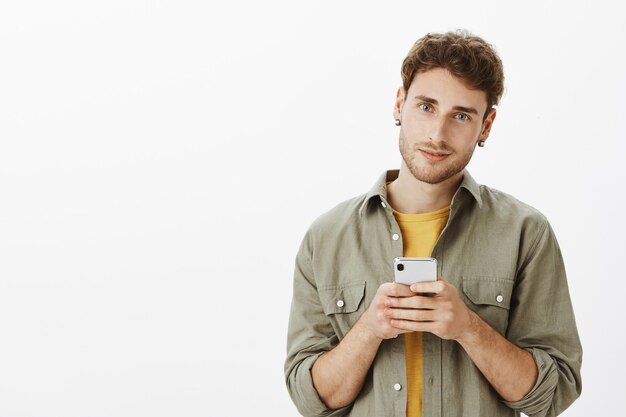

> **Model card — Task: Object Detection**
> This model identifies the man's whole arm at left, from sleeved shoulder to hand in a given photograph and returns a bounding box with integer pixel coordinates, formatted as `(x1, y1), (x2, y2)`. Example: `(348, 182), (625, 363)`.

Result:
(285, 231), (411, 417)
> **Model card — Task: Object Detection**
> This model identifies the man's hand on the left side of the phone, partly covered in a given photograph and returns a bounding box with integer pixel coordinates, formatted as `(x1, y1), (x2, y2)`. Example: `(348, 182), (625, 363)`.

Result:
(360, 282), (415, 339)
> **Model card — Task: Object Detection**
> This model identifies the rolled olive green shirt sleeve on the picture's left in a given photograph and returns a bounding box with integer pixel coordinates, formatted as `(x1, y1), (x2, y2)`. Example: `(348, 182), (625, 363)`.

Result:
(285, 234), (350, 417)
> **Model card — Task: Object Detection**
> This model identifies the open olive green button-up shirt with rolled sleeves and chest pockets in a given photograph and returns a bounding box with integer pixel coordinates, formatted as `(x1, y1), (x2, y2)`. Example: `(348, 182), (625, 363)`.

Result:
(285, 171), (582, 417)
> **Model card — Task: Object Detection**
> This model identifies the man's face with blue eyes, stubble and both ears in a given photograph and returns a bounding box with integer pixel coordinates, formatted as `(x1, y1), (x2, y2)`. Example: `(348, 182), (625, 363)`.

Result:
(394, 68), (496, 184)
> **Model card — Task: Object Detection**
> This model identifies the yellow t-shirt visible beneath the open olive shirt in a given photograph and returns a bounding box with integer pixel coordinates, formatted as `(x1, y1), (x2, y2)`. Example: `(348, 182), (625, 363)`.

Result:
(393, 207), (450, 417)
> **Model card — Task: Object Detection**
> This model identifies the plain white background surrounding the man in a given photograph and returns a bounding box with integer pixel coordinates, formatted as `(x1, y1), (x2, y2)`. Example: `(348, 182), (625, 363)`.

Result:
(0, 0), (626, 417)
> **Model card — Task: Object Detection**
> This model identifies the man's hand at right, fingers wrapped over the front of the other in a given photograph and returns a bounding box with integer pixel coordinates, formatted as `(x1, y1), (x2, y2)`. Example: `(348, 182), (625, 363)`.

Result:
(384, 277), (473, 340)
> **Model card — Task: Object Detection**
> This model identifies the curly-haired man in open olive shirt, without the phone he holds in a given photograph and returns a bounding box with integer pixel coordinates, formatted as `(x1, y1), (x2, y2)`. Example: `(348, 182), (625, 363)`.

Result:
(285, 32), (582, 417)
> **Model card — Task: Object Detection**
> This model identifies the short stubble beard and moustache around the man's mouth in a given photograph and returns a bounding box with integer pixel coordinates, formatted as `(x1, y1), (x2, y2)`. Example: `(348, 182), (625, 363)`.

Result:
(400, 132), (475, 184)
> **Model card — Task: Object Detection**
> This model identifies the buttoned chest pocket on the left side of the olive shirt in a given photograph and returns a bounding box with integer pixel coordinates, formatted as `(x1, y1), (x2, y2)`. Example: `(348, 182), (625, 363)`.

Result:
(318, 281), (365, 339)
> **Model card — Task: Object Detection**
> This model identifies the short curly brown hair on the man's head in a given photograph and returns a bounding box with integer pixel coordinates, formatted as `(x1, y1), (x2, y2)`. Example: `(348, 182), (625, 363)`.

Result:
(401, 30), (504, 117)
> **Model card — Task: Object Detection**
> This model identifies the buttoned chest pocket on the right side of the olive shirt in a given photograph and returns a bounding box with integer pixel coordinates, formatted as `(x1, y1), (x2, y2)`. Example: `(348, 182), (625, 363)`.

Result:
(463, 276), (515, 335)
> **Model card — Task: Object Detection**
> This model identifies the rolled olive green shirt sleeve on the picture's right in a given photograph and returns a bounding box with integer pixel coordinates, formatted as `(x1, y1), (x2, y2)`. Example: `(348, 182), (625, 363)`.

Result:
(504, 219), (582, 417)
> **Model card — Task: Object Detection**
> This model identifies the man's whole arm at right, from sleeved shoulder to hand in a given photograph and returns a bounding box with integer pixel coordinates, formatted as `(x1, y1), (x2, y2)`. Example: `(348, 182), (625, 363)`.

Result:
(386, 219), (582, 416)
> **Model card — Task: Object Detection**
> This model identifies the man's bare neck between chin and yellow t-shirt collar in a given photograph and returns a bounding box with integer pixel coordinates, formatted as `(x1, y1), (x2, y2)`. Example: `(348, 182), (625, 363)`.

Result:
(387, 161), (463, 214)
